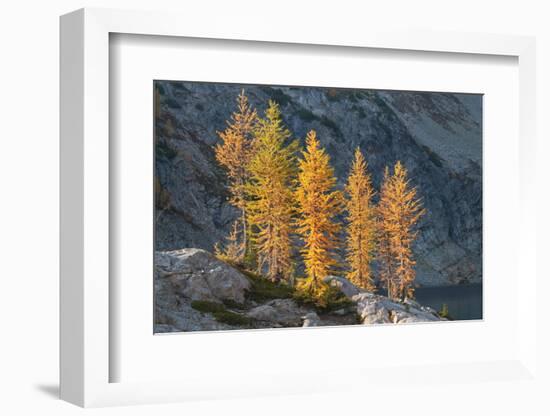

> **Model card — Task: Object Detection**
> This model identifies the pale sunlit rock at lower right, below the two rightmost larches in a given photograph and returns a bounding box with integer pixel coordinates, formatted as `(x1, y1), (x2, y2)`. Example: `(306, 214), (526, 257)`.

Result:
(353, 292), (444, 324)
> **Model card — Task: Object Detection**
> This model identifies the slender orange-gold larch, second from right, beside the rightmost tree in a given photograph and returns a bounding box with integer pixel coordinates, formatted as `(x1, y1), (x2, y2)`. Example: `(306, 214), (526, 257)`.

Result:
(345, 148), (376, 291)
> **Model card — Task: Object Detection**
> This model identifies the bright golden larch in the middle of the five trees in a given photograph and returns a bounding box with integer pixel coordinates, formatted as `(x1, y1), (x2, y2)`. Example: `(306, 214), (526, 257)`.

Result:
(296, 130), (343, 306)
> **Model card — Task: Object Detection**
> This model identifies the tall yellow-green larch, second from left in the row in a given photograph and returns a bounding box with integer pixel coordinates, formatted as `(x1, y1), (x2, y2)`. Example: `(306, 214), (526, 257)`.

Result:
(246, 101), (298, 281)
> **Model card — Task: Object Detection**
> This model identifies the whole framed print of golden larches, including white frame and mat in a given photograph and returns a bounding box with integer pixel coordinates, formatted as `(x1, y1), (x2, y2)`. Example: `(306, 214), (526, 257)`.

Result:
(61, 9), (537, 406)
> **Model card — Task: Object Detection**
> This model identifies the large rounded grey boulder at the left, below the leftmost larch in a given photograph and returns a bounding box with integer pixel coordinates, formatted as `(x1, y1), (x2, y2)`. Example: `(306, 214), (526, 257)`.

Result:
(155, 248), (250, 303)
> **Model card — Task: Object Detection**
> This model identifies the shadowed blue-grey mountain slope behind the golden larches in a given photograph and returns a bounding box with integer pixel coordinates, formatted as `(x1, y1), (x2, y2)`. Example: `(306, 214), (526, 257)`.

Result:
(155, 81), (482, 286)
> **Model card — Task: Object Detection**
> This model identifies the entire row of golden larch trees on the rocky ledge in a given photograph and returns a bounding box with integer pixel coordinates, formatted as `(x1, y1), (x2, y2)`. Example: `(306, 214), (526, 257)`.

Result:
(212, 91), (432, 306)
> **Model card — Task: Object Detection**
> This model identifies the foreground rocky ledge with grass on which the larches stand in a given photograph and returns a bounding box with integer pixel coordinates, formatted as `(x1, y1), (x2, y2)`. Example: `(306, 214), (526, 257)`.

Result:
(154, 248), (443, 333)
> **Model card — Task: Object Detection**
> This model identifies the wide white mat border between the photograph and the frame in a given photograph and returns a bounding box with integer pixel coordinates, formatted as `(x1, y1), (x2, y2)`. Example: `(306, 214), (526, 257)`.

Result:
(110, 34), (519, 383)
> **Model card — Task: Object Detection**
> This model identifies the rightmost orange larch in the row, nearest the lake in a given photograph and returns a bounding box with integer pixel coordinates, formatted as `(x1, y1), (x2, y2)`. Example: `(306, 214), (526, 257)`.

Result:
(378, 161), (426, 300)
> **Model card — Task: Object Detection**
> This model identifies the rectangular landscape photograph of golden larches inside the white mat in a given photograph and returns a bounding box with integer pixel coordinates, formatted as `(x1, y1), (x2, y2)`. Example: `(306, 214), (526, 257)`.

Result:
(151, 80), (483, 333)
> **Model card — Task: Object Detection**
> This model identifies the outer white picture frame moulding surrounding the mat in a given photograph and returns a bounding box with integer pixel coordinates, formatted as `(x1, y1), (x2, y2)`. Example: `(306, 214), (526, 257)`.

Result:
(60, 9), (537, 407)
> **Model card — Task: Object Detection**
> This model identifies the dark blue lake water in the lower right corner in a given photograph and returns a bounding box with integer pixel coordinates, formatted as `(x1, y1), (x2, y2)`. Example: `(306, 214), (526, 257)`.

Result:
(414, 284), (483, 320)
